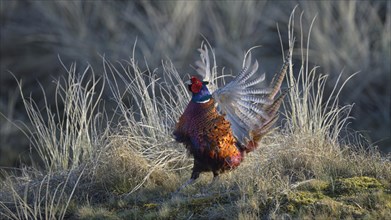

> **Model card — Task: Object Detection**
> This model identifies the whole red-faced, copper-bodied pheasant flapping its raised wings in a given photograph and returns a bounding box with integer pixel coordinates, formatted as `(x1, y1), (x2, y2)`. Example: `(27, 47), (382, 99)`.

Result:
(173, 44), (291, 191)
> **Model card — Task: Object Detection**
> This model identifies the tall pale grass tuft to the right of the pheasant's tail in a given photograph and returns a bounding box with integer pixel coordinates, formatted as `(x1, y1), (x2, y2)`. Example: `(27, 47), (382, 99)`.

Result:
(285, 11), (357, 146)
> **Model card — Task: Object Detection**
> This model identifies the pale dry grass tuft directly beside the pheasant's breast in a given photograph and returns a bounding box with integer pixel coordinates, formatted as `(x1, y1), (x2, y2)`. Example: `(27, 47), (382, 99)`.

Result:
(89, 50), (194, 194)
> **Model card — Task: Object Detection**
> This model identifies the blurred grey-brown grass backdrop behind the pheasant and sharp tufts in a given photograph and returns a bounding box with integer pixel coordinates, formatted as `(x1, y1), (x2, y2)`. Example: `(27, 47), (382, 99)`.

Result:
(0, 1), (391, 166)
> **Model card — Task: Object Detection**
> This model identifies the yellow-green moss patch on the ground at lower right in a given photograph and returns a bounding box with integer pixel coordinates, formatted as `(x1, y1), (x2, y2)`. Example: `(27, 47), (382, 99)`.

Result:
(283, 177), (391, 219)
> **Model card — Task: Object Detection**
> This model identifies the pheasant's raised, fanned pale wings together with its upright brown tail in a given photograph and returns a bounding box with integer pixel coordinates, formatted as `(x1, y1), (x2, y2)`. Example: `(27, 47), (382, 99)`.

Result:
(196, 46), (290, 148)
